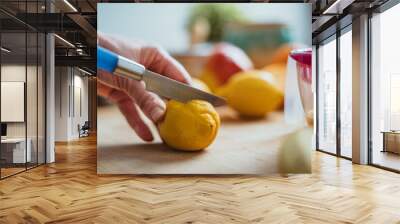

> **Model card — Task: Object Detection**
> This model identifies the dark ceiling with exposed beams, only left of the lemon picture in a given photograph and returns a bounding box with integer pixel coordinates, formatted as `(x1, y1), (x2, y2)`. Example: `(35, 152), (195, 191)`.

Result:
(0, 0), (98, 71)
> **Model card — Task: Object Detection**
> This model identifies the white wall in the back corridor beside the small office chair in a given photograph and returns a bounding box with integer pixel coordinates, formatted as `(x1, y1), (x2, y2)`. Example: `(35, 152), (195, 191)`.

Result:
(55, 67), (88, 141)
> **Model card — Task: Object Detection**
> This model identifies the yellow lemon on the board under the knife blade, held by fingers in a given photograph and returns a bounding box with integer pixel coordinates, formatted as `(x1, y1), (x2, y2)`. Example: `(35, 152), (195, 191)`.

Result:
(159, 100), (220, 151)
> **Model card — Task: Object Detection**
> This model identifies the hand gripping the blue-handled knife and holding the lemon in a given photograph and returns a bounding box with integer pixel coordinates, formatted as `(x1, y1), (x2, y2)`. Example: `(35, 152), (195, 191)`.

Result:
(97, 34), (190, 141)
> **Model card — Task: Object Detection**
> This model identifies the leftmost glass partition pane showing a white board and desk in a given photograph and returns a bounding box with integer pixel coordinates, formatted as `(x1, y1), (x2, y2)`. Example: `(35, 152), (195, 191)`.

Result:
(0, 30), (27, 178)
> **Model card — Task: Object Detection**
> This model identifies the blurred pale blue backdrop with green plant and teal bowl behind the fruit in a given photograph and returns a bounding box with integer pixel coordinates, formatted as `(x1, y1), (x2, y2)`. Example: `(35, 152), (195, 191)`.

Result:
(98, 3), (311, 77)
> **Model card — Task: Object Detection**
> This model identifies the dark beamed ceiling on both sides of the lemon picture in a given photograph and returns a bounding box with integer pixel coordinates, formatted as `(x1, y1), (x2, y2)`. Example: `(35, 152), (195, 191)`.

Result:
(0, 0), (394, 71)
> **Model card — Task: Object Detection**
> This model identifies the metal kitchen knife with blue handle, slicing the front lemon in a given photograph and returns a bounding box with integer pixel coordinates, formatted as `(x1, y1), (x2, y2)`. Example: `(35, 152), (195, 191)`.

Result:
(97, 46), (225, 106)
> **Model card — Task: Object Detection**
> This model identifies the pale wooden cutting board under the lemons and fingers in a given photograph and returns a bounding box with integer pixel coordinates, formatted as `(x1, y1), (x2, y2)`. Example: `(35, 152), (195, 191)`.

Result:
(97, 106), (296, 175)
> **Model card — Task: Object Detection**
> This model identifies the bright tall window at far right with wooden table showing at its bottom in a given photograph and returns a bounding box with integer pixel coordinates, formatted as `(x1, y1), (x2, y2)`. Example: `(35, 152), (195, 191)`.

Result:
(370, 4), (400, 170)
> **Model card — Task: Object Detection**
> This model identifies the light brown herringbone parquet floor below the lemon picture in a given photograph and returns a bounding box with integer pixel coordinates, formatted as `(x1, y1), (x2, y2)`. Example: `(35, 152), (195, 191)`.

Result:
(0, 137), (400, 224)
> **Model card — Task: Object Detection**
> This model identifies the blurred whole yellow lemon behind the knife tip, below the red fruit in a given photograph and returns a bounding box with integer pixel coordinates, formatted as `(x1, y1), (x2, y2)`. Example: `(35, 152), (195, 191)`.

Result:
(217, 70), (283, 117)
